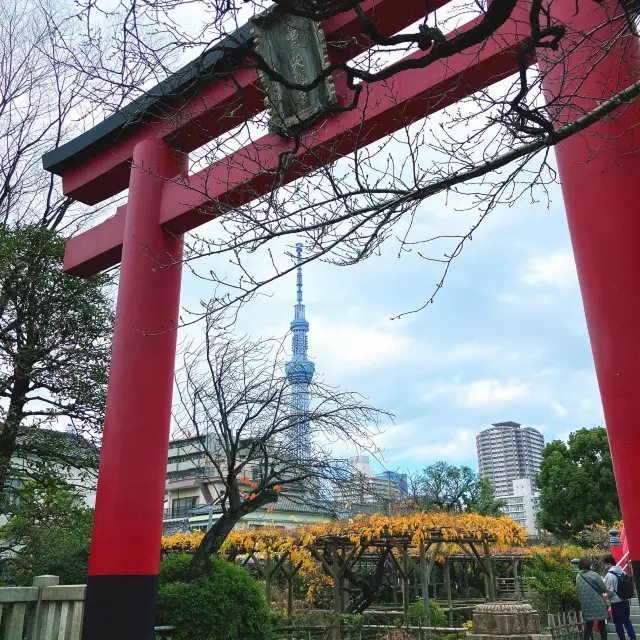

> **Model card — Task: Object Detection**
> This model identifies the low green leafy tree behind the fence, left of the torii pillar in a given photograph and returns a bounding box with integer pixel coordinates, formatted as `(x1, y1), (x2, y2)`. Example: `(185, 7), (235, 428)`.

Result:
(0, 476), (93, 585)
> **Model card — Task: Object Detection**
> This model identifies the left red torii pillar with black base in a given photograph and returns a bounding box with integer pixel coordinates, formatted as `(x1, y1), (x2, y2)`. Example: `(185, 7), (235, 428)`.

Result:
(76, 138), (186, 640)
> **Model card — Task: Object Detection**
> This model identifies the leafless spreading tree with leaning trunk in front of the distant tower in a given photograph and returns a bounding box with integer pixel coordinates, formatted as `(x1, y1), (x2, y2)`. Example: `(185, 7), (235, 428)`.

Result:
(174, 324), (386, 578)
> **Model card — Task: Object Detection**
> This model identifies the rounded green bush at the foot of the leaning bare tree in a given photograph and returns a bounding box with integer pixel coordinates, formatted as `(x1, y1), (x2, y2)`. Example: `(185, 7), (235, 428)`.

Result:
(156, 554), (273, 640)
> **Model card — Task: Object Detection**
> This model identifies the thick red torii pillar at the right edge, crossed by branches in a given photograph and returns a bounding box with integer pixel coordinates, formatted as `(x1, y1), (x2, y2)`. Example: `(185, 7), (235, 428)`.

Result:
(540, 1), (640, 576)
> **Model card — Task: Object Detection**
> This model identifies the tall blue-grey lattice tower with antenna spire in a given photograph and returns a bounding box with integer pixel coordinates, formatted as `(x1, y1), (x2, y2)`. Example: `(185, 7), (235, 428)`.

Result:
(285, 242), (315, 458)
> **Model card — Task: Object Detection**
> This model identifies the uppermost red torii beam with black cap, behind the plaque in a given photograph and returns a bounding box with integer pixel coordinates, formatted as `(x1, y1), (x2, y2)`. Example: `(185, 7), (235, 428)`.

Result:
(43, 0), (450, 204)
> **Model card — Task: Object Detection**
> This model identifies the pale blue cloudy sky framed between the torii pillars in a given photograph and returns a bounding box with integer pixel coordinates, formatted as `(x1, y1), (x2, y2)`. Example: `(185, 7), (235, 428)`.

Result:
(176, 145), (603, 478)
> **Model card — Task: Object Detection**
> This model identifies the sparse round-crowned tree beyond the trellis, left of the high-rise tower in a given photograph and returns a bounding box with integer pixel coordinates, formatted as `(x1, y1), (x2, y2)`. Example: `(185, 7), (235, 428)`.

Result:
(407, 461), (504, 516)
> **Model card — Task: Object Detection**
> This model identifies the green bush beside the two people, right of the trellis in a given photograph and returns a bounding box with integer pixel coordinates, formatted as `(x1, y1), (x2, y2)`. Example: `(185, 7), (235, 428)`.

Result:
(525, 555), (580, 614)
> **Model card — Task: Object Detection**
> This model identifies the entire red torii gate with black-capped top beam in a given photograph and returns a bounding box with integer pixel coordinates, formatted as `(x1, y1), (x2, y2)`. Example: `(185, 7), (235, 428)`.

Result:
(43, 0), (640, 640)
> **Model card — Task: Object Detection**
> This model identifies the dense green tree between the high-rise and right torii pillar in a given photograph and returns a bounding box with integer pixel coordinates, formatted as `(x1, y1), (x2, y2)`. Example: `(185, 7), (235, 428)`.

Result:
(536, 427), (620, 538)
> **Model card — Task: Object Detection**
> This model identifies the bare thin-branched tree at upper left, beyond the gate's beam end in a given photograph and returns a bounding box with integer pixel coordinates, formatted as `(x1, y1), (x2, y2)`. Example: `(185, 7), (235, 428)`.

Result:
(0, 0), (138, 234)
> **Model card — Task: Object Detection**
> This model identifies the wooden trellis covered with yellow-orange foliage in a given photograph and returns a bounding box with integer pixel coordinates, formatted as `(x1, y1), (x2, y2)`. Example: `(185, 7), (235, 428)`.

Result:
(163, 512), (525, 637)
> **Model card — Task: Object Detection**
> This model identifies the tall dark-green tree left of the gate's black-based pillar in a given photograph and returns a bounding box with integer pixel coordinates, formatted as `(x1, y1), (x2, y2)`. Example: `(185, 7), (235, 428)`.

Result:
(0, 225), (113, 513)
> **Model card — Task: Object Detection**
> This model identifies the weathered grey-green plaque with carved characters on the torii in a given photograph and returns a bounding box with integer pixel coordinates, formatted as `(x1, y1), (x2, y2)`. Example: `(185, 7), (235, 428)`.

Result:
(251, 7), (337, 138)
